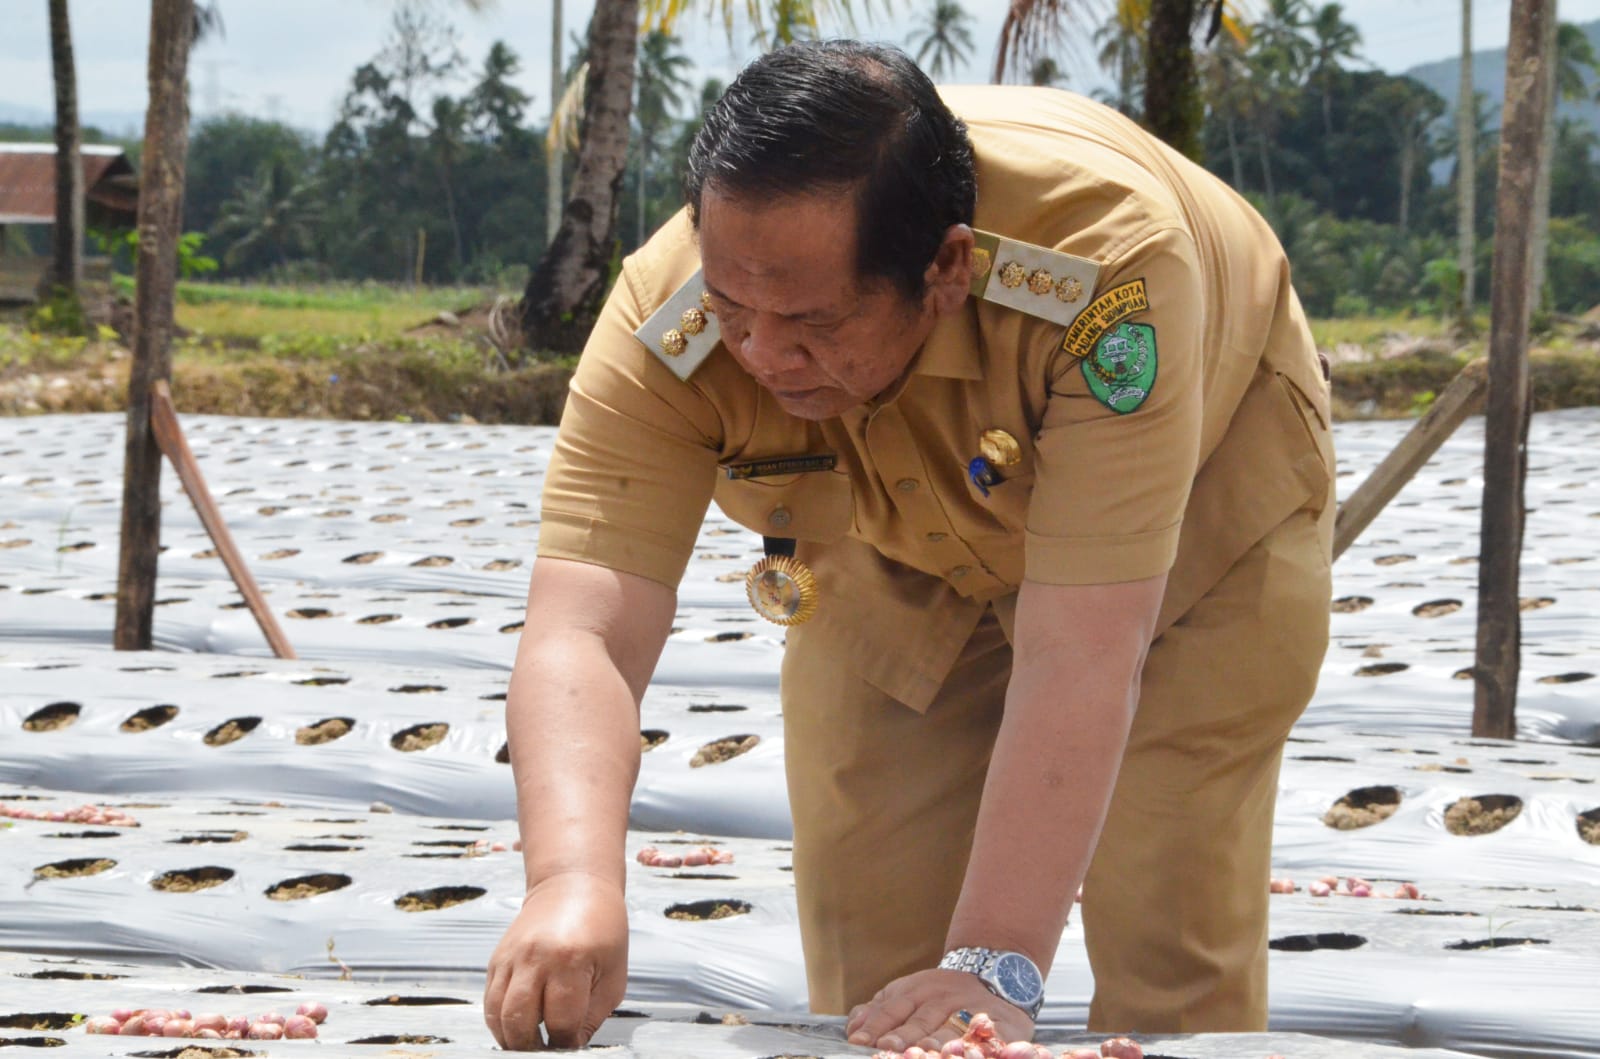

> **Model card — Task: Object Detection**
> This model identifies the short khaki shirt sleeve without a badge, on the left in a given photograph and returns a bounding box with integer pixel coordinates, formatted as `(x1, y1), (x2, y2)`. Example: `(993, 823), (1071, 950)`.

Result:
(539, 259), (722, 589)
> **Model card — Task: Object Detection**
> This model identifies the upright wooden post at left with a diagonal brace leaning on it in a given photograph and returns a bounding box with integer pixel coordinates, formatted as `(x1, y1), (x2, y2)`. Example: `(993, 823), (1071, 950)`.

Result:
(112, 0), (194, 651)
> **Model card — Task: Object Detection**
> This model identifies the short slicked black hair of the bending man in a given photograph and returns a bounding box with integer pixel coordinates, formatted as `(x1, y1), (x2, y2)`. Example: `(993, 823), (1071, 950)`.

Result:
(683, 40), (978, 298)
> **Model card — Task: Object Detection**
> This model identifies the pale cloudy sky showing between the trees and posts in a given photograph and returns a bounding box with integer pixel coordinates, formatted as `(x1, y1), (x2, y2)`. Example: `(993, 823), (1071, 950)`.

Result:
(0, 0), (1600, 134)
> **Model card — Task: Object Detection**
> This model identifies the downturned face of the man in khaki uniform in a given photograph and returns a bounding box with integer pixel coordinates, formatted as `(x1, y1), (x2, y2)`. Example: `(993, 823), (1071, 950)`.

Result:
(699, 187), (934, 419)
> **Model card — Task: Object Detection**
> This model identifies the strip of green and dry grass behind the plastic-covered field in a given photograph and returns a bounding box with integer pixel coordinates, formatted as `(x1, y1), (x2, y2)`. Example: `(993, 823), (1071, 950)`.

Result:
(9, 287), (1600, 424)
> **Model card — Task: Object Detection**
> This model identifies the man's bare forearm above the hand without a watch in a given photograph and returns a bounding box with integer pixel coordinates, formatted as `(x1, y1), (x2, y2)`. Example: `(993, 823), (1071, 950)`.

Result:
(506, 632), (638, 889)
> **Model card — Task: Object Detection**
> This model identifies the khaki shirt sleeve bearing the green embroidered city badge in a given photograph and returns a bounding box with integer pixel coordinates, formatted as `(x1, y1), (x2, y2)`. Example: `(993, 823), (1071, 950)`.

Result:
(1026, 227), (1208, 584)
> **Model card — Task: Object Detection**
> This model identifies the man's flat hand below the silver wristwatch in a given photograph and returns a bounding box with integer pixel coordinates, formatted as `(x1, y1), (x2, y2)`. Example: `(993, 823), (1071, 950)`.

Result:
(845, 968), (1034, 1051)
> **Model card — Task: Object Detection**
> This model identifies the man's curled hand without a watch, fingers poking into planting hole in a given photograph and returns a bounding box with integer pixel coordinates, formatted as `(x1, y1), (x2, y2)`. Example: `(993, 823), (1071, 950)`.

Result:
(483, 872), (627, 1051)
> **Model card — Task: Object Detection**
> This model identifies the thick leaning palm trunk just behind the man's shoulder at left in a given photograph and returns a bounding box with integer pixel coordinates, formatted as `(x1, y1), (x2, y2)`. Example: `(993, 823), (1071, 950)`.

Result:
(520, 0), (638, 354)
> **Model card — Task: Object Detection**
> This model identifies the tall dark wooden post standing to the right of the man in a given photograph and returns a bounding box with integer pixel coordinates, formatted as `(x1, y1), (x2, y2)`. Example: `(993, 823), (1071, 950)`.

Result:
(1472, 0), (1555, 739)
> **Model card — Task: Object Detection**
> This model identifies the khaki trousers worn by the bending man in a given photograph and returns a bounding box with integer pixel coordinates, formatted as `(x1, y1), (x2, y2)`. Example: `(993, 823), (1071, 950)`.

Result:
(782, 504), (1334, 1033)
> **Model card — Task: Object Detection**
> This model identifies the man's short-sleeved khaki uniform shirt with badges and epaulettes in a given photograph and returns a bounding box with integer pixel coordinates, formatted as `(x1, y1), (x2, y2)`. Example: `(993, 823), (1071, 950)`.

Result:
(539, 86), (1331, 709)
